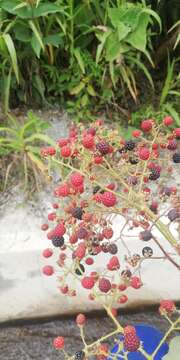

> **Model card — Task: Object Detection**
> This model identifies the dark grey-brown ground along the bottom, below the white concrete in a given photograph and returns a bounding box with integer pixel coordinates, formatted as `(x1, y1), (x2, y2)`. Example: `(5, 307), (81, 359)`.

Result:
(0, 311), (168, 360)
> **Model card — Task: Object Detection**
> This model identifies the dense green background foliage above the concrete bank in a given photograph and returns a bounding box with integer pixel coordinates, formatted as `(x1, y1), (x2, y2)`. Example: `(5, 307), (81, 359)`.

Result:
(0, 0), (180, 119)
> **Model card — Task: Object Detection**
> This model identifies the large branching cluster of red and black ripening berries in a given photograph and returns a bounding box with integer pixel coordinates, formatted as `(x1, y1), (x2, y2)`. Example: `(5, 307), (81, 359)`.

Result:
(41, 117), (180, 359)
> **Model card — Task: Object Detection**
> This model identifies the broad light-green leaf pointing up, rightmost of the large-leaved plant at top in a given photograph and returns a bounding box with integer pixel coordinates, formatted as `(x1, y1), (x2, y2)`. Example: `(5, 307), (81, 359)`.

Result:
(125, 14), (149, 52)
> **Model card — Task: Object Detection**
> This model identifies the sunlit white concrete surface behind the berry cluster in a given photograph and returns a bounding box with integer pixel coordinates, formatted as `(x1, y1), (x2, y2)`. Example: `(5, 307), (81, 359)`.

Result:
(0, 197), (180, 322)
